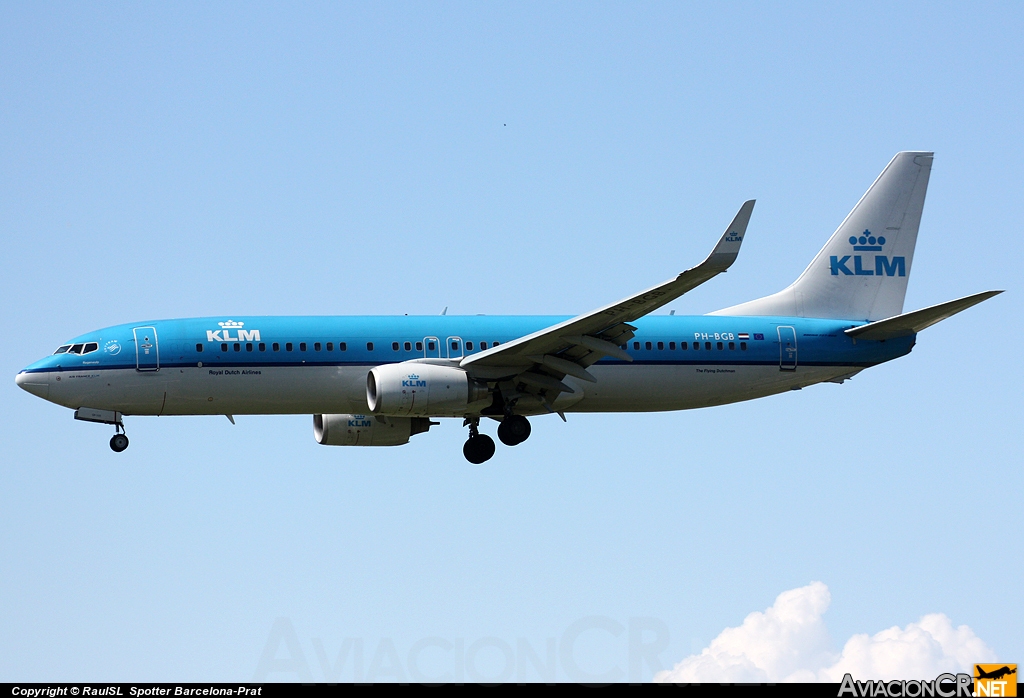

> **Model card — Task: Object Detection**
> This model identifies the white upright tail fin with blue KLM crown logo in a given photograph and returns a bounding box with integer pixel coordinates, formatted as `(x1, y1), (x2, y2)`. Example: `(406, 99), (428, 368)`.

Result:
(711, 151), (933, 320)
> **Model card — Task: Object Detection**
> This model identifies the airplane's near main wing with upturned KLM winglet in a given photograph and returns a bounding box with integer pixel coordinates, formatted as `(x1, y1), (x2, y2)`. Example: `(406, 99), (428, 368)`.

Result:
(461, 200), (754, 409)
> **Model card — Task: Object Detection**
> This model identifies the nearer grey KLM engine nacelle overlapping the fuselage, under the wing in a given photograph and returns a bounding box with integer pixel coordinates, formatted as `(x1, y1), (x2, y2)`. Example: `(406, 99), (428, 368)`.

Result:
(367, 361), (490, 417)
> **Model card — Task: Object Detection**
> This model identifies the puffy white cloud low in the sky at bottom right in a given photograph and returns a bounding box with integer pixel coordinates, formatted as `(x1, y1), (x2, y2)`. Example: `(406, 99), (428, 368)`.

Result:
(654, 581), (995, 683)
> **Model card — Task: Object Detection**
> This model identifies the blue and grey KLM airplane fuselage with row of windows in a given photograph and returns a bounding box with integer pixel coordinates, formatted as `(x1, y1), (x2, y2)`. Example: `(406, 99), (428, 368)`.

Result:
(18, 315), (914, 417)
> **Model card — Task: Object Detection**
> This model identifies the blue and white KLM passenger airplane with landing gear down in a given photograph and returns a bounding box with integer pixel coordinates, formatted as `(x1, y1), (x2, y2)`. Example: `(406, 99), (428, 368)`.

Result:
(15, 151), (1002, 464)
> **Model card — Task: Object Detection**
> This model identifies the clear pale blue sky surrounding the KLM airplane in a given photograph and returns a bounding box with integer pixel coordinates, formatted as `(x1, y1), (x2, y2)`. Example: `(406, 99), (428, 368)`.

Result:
(0, 2), (1024, 681)
